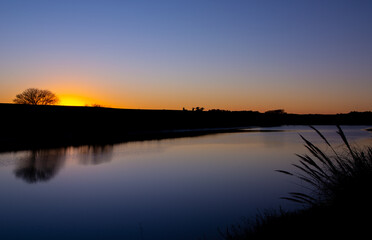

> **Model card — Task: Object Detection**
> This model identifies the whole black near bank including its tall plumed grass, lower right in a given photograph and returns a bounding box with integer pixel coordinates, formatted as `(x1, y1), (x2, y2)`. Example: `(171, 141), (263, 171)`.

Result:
(221, 128), (372, 240)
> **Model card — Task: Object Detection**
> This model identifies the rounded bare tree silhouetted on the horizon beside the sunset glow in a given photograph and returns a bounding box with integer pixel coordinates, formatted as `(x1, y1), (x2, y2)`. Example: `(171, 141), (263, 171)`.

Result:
(13, 88), (59, 105)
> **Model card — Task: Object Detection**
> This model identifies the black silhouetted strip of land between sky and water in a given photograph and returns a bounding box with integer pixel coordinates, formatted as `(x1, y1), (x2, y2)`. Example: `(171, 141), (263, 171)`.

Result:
(0, 104), (372, 151)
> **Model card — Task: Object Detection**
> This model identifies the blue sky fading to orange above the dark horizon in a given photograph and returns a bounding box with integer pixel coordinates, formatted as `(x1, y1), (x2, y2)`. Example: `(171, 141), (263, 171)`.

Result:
(0, 0), (372, 113)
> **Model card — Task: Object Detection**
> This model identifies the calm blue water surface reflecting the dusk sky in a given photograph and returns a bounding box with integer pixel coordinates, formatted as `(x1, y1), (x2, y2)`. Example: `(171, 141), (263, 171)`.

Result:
(0, 126), (372, 240)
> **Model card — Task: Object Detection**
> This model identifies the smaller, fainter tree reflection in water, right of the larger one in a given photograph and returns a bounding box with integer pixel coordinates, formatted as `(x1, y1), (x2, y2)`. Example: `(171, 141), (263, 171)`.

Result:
(78, 145), (114, 165)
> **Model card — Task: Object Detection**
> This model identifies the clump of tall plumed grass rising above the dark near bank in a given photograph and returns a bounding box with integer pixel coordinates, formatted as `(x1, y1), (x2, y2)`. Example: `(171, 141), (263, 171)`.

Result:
(279, 126), (372, 207)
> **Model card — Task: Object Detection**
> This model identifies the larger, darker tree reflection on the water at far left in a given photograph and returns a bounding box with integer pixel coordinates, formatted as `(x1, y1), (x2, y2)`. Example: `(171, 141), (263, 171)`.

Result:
(14, 148), (66, 183)
